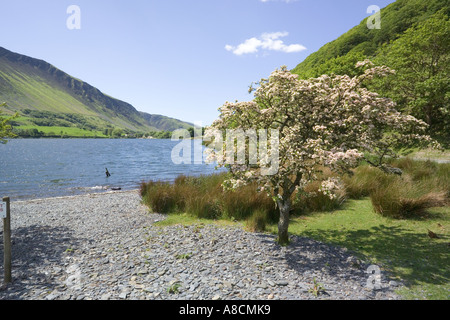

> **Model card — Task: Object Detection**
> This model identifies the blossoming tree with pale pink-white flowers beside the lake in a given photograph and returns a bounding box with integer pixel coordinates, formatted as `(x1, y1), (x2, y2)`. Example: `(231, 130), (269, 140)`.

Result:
(205, 61), (431, 244)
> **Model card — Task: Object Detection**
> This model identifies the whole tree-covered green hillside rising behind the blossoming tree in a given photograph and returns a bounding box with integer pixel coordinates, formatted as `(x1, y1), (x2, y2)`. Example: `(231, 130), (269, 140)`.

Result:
(292, 0), (450, 148)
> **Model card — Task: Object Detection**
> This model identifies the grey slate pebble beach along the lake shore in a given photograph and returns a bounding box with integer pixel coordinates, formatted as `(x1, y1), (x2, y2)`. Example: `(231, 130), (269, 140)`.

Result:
(0, 190), (401, 300)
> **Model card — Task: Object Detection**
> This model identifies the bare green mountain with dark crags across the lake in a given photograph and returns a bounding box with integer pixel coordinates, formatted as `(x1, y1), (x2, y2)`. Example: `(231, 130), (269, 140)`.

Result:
(0, 47), (193, 132)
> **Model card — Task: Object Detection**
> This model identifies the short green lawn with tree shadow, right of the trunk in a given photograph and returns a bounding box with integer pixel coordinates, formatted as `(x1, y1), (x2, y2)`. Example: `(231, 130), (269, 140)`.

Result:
(268, 199), (450, 300)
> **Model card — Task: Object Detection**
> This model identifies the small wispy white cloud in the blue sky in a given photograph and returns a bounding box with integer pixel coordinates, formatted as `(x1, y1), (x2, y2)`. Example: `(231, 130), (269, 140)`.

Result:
(225, 31), (306, 56)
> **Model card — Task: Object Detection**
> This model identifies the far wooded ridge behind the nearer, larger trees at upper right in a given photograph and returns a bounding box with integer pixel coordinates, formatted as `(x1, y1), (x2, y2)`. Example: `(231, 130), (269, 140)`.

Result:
(292, 0), (450, 79)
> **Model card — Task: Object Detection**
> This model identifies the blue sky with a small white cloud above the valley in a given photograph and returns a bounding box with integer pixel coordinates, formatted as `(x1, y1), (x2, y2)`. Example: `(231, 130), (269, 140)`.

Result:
(0, 0), (394, 125)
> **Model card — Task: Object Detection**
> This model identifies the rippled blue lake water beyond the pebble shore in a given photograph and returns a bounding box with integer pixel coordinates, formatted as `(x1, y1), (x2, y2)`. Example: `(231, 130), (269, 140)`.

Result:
(0, 139), (224, 201)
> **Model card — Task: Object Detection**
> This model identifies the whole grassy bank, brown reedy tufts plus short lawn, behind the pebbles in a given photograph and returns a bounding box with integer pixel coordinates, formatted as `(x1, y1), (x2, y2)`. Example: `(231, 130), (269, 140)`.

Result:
(141, 158), (450, 299)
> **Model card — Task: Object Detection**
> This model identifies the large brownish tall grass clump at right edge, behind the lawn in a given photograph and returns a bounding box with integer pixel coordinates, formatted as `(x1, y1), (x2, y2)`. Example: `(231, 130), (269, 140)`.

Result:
(343, 158), (450, 219)
